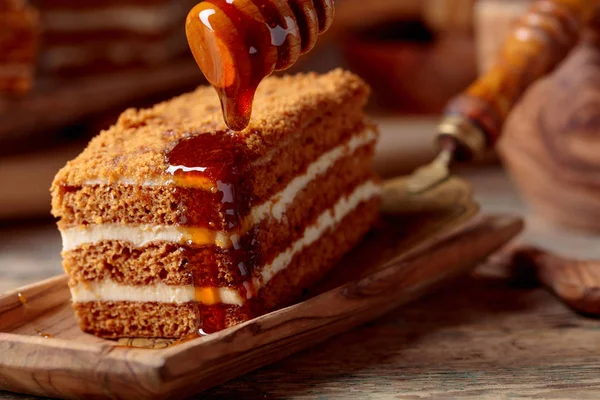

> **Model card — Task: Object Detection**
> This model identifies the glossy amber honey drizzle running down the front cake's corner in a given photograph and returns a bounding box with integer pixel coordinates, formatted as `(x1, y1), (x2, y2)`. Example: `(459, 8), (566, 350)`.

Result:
(166, 131), (256, 333)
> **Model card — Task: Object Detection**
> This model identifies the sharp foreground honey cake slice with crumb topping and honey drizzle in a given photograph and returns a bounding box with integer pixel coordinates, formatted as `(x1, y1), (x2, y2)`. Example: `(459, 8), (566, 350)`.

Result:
(52, 70), (381, 338)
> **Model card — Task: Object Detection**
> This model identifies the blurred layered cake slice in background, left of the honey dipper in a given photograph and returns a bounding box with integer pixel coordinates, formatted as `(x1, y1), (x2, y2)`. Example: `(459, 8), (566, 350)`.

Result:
(36, 0), (197, 76)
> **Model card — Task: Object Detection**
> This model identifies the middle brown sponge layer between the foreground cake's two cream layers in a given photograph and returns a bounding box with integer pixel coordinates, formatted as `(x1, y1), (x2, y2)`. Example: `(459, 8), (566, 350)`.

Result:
(63, 142), (374, 286)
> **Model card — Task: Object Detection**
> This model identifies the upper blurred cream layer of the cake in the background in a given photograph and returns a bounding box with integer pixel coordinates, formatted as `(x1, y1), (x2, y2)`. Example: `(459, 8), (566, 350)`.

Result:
(43, 1), (186, 34)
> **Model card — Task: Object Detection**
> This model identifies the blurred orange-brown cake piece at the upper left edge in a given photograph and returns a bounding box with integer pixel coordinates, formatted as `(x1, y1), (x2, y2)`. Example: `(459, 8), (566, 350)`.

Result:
(0, 0), (39, 95)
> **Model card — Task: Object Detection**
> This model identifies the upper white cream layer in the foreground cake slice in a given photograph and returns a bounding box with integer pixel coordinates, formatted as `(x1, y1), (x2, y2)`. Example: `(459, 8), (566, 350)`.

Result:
(61, 129), (377, 251)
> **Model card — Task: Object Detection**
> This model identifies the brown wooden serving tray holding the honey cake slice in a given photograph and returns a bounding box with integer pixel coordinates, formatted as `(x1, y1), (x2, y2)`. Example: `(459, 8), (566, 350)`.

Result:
(0, 179), (522, 399)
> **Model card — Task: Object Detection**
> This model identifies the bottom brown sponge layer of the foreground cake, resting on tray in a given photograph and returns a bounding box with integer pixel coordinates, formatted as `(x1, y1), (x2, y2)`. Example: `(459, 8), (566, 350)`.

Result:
(74, 198), (379, 338)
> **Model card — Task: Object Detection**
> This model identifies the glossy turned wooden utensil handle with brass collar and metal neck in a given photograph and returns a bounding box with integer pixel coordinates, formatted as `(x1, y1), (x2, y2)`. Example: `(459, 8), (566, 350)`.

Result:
(406, 0), (599, 194)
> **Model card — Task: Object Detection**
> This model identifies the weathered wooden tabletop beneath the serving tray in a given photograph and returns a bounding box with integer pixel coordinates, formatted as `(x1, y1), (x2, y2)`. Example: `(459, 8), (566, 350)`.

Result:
(0, 120), (600, 399)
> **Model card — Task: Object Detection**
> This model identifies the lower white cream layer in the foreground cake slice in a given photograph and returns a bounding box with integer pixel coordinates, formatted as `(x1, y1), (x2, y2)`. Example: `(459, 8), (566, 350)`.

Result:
(71, 181), (381, 305)
